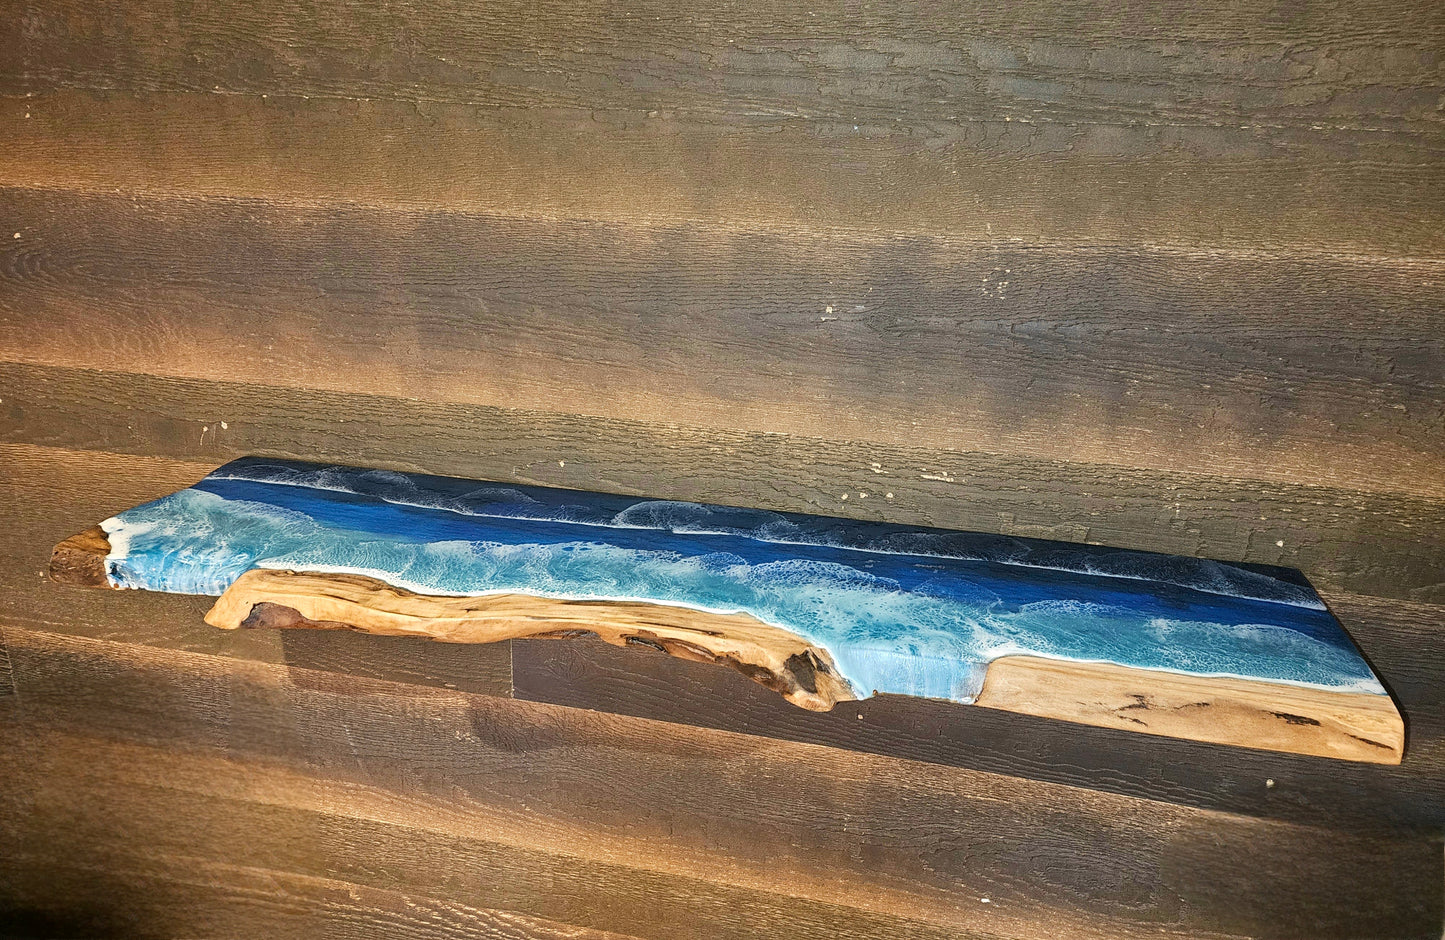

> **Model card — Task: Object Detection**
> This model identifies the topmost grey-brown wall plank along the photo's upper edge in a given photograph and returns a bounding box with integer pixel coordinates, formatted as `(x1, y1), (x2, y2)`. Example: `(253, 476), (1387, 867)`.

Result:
(0, 0), (1445, 133)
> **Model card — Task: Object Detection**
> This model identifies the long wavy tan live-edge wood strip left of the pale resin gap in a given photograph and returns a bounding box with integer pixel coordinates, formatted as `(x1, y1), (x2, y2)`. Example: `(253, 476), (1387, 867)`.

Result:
(205, 569), (855, 712)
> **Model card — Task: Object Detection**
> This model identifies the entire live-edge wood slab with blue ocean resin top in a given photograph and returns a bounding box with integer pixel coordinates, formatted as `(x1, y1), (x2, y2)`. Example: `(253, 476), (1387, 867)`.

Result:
(51, 458), (1405, 764)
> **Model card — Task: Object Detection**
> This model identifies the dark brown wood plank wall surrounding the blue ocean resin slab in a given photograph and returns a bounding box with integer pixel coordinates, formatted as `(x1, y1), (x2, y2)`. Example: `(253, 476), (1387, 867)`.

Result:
(0, 0), (1445, 939)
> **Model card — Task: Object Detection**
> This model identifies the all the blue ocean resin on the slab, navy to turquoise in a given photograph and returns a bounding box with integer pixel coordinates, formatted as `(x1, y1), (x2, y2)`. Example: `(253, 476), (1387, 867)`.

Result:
(101, 458), (1384, 702)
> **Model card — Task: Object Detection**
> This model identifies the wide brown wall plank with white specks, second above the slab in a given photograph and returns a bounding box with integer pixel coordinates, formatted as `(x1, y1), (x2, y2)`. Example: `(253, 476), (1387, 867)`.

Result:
(0, 188), (1445, 497)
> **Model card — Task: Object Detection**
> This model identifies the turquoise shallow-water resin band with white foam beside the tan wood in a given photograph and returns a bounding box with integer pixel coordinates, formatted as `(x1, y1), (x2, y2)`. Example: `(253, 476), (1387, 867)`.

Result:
(105, 489), (1379, 700)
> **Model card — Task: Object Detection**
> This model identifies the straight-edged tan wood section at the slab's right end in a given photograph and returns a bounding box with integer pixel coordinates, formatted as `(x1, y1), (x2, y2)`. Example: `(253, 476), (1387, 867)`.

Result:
(975, 656), (1405, 764)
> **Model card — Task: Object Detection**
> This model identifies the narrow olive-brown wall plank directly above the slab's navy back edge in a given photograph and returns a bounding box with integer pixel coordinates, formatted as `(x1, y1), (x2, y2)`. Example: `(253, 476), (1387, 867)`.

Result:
(0, 362), (1445, 601)
